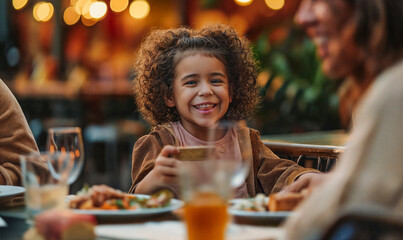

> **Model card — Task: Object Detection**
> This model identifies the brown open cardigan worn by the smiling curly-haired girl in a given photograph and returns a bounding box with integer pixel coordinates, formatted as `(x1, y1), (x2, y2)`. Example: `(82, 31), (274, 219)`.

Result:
(129, 125), (316, 197)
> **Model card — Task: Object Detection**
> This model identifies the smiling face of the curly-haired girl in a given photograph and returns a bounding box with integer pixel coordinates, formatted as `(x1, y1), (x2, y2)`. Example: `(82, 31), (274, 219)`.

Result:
(165, 54), (232, 139)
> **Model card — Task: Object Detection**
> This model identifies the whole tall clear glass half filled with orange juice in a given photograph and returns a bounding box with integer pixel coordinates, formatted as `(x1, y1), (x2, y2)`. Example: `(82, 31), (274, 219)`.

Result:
(179, 160), (231, 240)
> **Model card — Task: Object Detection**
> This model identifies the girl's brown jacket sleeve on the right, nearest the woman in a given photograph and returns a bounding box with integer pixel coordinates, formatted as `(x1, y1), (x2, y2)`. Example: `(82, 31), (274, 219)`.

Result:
(247, 129), (319, 196)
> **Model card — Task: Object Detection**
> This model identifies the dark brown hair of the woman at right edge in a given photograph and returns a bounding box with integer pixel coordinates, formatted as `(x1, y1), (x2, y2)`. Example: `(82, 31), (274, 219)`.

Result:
(345, 0), (403, 75)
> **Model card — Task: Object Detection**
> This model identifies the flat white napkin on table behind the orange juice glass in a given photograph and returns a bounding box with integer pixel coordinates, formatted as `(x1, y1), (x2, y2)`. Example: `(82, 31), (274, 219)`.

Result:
(95, 221), (284, 240)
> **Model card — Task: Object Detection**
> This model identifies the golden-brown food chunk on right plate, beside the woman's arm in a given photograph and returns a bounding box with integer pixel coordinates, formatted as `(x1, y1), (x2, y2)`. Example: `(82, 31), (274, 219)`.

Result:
(268, 190), (309, 212)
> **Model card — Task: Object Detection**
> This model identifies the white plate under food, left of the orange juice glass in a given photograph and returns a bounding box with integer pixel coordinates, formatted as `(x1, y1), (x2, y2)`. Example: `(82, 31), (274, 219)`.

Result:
(69, 194), (183, 218)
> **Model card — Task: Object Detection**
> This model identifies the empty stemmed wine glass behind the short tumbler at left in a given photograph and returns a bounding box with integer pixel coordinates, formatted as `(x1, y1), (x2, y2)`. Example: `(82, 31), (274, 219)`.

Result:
(46, 127), (84, 184)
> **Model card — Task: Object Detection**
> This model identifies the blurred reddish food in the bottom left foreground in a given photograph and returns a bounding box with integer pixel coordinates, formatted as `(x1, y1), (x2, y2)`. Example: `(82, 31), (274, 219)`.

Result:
(23, 209), (97, 240)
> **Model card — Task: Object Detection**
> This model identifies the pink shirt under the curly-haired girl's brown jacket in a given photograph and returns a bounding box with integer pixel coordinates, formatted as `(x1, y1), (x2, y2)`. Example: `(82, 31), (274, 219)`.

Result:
(170, 121), (248, 198)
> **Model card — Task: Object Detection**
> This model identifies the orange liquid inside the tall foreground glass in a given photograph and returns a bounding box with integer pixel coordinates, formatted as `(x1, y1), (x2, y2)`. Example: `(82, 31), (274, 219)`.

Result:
(185, 192), (229, 240)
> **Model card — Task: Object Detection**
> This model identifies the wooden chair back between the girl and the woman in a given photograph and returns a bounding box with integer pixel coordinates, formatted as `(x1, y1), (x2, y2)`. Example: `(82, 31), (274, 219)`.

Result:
(263, 141), (344, 172)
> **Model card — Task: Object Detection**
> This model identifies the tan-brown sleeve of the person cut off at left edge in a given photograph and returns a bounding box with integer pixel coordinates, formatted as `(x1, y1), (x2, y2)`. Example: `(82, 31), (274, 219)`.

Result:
(0, 79), (46, 185)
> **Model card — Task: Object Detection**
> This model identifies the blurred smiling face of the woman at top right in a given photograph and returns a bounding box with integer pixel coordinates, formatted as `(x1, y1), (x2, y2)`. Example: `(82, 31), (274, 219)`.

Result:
(295, 0), (363, 78)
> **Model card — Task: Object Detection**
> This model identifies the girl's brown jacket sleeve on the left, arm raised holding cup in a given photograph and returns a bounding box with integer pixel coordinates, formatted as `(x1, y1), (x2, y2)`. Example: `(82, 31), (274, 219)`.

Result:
(129, 125), (178, 193)
